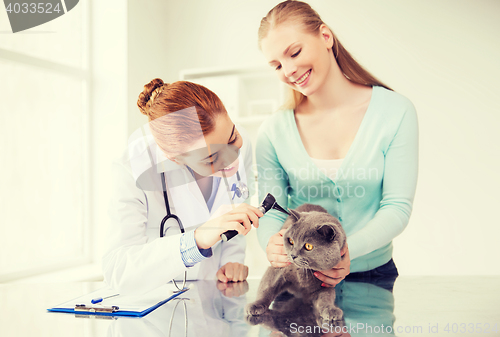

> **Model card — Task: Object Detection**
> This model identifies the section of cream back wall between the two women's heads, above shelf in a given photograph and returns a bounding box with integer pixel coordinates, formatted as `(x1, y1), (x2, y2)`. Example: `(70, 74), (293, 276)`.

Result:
(128, 0), (274, 132)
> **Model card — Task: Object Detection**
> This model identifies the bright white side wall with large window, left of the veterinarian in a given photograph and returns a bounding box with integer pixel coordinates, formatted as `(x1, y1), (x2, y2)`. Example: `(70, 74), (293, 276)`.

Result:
(0, 0), (128, 282)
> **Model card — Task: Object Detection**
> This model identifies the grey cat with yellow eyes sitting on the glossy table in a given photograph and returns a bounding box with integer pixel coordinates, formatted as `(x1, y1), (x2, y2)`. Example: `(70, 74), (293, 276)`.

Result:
(246, 204), (346, 326)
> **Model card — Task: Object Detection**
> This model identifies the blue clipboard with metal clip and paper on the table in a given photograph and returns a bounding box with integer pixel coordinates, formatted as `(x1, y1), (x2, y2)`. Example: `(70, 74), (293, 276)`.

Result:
(47, 284), (189, 318)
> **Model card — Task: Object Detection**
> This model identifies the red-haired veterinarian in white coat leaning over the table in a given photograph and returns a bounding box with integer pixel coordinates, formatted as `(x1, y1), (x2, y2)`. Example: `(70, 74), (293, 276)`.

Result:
(103, 79), (263, 293)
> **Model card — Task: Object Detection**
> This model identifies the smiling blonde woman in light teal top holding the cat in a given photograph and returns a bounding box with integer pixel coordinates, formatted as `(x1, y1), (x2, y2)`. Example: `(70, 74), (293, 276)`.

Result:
(256, 1), (418, 286)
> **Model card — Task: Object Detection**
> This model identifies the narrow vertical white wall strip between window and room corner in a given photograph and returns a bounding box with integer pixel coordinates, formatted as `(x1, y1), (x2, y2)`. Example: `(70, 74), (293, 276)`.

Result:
(89, 0), (128, 266)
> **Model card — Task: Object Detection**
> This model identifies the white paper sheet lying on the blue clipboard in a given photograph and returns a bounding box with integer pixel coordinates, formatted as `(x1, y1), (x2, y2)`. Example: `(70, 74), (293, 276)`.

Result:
(47, 284), (188, 316)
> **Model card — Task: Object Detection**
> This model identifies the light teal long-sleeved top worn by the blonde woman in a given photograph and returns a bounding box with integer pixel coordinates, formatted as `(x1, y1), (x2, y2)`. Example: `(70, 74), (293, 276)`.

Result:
(256, 86), (418, 272)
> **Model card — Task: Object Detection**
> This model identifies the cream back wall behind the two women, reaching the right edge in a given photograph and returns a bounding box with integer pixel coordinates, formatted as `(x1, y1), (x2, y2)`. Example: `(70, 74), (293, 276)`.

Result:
(127, 0), (500, 275)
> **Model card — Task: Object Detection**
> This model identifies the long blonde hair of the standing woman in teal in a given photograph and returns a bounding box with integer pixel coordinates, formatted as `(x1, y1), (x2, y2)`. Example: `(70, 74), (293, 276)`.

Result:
(258, 0), (392, 109)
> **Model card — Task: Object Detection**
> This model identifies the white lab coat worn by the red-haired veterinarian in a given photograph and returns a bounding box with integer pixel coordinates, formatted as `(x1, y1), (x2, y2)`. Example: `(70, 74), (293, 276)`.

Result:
(102, 127), (255, 293)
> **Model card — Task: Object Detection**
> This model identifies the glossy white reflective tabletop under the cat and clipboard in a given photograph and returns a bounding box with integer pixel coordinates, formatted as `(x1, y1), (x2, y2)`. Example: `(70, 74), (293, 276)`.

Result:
(0, 276), (500, 337)
